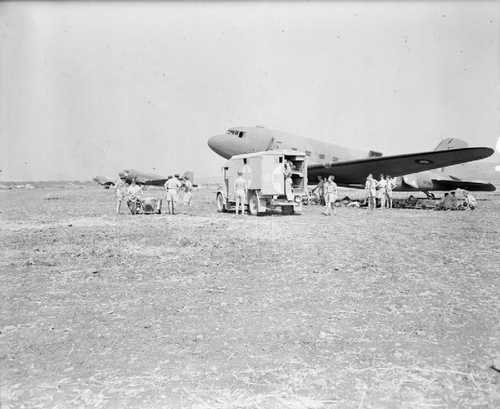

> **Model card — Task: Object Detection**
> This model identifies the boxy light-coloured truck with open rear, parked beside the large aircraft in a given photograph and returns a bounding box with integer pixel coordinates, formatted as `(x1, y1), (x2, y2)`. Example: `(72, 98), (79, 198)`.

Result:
(217, 150), (307, 215)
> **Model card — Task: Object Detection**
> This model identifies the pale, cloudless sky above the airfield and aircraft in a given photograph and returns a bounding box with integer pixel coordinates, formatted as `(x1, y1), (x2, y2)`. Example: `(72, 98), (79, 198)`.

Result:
(0, 1), (500, 181)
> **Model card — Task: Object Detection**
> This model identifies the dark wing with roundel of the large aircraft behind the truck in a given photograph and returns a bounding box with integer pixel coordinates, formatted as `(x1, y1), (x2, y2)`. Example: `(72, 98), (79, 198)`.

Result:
(307, 147), (494, 185)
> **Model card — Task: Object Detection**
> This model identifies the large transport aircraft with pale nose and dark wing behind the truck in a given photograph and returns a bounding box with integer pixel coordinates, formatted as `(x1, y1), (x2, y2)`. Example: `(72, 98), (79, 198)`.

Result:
(208, 126), (494, 191)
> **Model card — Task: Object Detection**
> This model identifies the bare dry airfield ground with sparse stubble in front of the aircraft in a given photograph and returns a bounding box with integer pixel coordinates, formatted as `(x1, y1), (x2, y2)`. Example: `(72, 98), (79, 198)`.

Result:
(0, 186), (500, 409)
